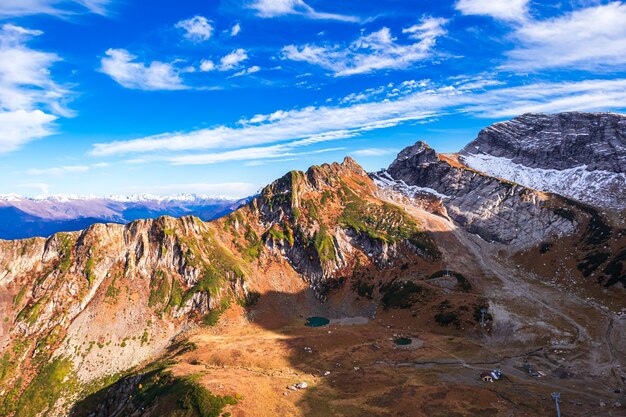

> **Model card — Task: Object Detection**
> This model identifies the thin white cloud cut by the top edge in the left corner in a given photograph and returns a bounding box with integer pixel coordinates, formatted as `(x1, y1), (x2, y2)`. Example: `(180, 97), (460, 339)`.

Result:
(0, 0), (111, 18)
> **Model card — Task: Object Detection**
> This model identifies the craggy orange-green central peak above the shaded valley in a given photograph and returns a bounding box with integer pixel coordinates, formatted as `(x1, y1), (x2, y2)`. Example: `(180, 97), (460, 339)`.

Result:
(226, 158), (437, 299)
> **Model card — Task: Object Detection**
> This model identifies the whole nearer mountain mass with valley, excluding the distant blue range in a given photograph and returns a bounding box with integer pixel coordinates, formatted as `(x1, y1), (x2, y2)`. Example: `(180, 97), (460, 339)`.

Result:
(0, 113), (626, 417)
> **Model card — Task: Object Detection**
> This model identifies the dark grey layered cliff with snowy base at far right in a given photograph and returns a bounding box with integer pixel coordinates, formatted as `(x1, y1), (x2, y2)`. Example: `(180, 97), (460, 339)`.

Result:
(460, 112), (626, 210)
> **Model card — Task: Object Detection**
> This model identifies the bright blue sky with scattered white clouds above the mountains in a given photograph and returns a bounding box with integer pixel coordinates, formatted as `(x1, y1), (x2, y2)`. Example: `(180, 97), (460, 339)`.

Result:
(0, 0), (626, 197)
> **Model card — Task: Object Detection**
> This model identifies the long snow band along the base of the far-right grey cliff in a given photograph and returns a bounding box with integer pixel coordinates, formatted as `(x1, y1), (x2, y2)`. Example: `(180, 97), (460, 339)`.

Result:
(461, 154), (626, 209)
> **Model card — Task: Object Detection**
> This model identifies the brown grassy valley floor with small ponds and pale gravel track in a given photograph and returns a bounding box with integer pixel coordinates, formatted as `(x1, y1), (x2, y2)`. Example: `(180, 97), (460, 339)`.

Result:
(157, 208), (626, 417)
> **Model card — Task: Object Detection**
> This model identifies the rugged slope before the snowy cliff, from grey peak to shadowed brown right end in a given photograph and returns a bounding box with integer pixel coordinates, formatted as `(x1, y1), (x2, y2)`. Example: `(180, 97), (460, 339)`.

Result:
(372, 142), (626, 286)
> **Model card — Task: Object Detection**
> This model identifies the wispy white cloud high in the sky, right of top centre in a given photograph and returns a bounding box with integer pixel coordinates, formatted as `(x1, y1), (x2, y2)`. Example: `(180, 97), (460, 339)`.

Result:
(282, 18), (446, 77)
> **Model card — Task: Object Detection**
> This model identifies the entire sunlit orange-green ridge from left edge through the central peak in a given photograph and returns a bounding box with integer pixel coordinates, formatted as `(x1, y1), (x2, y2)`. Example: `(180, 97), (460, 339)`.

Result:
(0, 159), (439, 416)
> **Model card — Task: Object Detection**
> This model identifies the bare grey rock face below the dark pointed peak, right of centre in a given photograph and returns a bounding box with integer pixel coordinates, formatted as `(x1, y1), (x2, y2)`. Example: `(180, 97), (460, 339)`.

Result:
(376, 142), (576, 249)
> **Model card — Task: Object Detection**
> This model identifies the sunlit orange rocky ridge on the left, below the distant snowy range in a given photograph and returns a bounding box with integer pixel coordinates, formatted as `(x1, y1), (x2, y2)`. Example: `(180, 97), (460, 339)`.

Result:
(0, 217), (254, 410)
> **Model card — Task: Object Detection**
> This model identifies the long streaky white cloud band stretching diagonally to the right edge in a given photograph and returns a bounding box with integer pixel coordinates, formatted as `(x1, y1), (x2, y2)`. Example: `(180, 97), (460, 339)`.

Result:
(91, 79), (626, 164)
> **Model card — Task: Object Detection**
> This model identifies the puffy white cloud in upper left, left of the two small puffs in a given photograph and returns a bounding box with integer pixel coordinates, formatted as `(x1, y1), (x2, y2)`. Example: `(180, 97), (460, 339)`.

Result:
(100, 49), (188, 90)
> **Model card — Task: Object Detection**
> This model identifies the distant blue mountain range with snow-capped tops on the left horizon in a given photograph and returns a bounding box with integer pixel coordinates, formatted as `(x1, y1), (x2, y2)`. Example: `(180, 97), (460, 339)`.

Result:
(0, 194), (247, 239)
